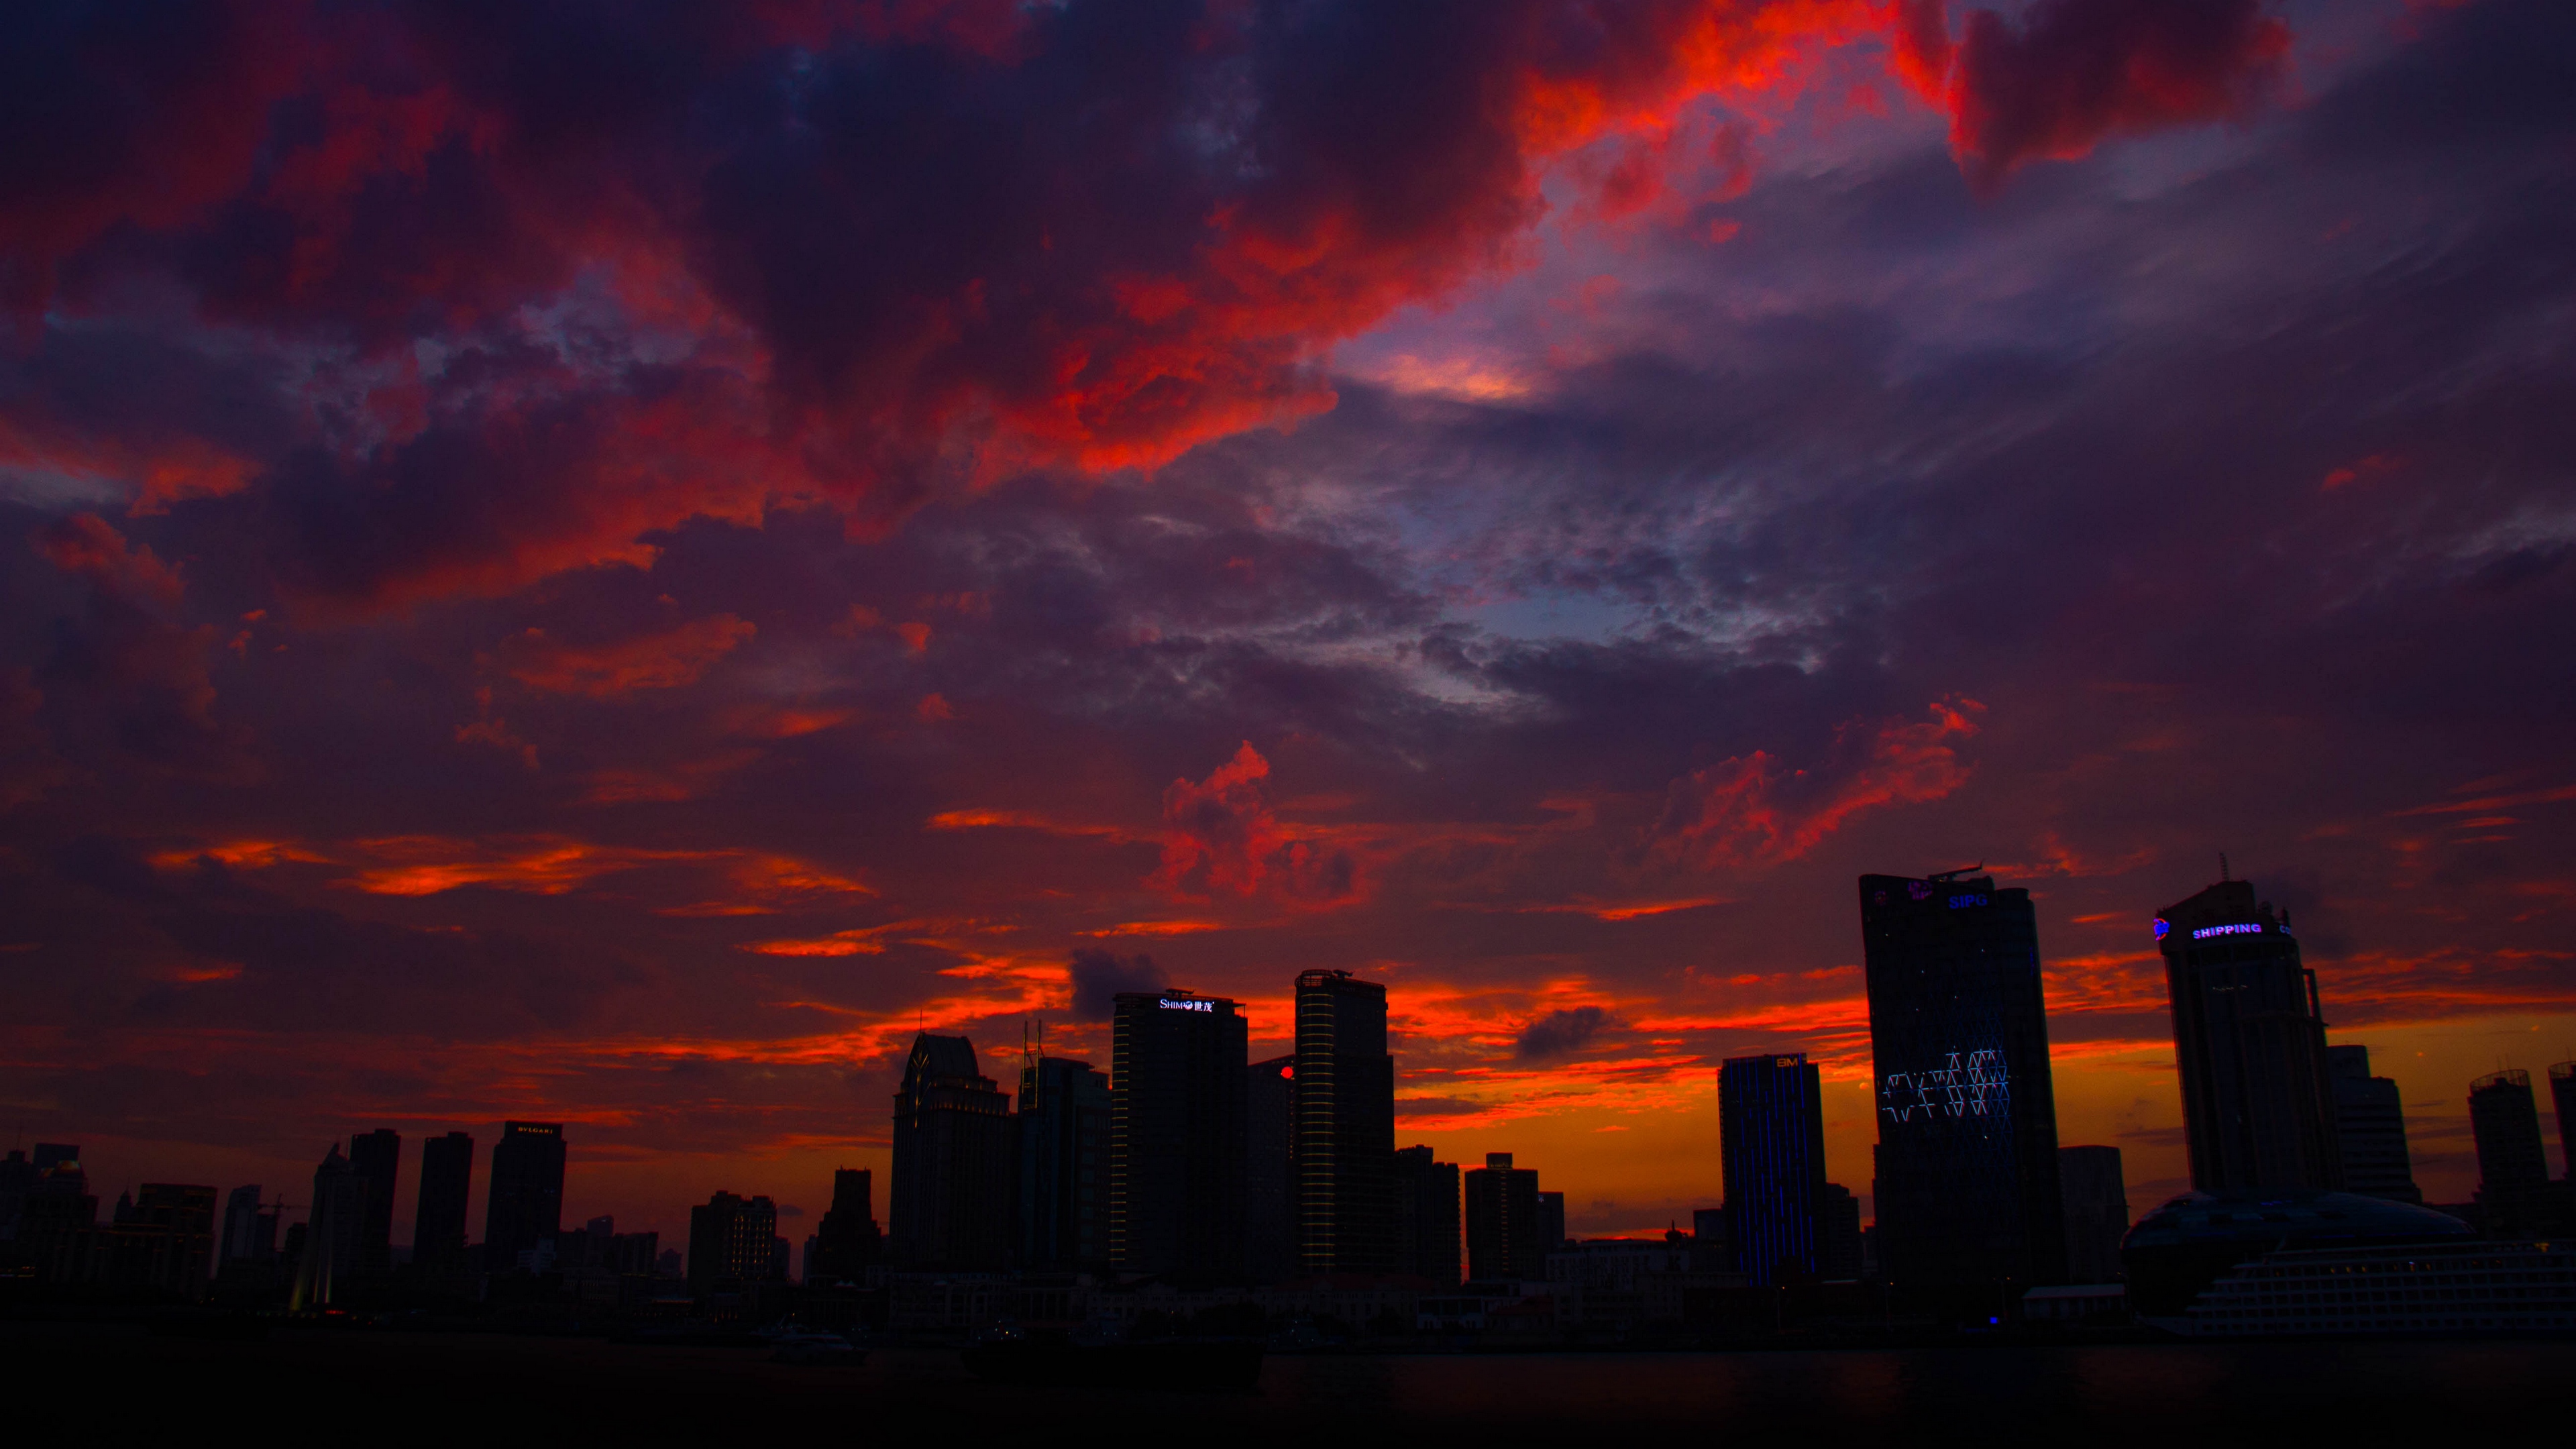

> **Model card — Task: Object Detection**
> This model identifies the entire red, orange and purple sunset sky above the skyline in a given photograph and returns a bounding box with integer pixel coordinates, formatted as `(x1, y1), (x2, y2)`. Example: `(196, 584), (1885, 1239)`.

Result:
(0, 0), (2576, 1243)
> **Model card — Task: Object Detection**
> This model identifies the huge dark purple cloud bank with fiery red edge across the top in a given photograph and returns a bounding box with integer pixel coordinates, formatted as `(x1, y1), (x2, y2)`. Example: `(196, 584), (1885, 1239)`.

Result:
(0, 0), (2318, 606)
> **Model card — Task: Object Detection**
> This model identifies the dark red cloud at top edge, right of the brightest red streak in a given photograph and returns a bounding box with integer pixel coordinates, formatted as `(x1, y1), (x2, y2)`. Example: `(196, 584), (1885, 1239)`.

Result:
(1937, 0), (2290, 186)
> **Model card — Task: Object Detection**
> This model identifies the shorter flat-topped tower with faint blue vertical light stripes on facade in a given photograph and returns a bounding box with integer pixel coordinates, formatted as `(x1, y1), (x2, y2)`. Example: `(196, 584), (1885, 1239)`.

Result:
(1718, 1052), (1858, 1287)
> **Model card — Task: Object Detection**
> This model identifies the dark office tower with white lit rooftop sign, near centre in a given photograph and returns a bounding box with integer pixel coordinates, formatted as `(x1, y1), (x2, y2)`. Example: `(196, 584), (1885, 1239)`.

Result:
(1110, 987), (1247, 1281)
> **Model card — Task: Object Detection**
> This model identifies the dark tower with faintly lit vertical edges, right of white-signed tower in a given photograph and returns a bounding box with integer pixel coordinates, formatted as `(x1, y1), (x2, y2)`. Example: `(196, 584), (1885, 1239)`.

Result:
(1288, 972), (1396, 1276)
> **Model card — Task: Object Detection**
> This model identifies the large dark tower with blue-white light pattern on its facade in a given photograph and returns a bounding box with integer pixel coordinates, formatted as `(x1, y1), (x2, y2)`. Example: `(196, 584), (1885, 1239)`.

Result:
(1860, 871), (2066, 1287)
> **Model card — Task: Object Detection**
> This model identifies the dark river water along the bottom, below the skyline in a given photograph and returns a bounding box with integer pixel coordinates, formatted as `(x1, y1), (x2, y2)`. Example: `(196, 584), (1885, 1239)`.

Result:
(0, 1326), (2576, 1449)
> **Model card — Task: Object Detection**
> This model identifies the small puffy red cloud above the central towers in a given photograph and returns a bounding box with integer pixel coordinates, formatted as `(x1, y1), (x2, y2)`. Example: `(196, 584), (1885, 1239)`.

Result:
(1151, 740), (1362, 905)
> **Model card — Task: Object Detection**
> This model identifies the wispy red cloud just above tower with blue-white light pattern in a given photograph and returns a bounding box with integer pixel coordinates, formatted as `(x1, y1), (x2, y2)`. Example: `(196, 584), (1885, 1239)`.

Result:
(1659, 699), (1984, 866)
